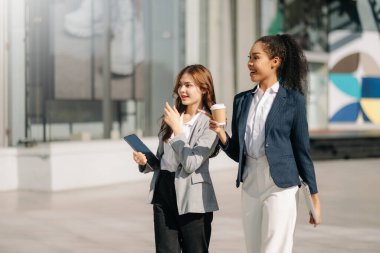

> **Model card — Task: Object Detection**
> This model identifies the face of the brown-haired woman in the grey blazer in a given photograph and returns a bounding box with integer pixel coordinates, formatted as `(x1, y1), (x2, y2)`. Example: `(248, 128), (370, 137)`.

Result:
(177, 73), (202, 107)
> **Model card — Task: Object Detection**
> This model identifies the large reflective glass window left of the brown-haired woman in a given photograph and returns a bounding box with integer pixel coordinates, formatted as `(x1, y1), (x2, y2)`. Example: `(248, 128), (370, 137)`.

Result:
(24, 0), (190, 141)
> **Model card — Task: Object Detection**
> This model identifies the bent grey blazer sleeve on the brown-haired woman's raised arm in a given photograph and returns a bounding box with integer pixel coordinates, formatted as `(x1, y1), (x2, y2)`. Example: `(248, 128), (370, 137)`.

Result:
(169, 124), (218, 173)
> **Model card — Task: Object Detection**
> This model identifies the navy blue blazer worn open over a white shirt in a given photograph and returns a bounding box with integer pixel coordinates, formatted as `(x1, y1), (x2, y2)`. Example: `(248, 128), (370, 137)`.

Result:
(221, 85), (318, 193)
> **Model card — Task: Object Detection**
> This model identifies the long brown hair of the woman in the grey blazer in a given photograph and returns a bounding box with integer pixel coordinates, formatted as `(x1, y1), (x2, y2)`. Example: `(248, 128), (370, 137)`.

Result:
(160, 64), (216, 141)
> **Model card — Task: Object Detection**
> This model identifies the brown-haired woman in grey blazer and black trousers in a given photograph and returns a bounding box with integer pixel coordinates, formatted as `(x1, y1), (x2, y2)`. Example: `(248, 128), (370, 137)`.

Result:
(133, 65), (218, 253)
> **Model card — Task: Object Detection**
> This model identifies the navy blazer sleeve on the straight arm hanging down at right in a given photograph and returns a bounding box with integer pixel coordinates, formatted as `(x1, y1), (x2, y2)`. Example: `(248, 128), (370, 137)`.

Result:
(290, 94), (318, 194)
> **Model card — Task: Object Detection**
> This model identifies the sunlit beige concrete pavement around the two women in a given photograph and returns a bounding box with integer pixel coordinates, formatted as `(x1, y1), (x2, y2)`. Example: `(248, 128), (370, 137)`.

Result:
(0, 159), (380, 253)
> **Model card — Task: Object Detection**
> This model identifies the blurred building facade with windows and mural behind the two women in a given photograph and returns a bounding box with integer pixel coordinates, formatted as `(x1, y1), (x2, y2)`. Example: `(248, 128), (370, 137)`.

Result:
(0, 0), (380, 189)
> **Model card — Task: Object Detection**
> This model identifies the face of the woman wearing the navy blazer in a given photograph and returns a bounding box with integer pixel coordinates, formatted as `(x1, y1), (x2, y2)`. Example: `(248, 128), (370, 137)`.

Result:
(248, 41), (278, 82)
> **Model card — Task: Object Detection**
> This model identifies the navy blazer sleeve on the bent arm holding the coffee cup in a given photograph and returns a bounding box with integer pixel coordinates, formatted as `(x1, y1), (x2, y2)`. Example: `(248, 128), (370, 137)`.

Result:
(219, 96), (240, 162)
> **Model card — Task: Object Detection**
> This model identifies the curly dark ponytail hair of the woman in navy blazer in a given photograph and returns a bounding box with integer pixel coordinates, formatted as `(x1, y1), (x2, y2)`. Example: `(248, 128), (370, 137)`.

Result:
(255, 34), (309, 95)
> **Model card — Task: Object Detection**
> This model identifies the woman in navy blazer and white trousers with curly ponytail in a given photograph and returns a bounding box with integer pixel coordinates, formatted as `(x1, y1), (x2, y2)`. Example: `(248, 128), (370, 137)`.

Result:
(210, 34), (320, 253)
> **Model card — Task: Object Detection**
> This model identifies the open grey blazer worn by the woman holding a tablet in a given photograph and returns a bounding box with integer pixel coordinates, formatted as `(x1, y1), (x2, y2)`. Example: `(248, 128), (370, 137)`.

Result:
(143, 113), (219, 215)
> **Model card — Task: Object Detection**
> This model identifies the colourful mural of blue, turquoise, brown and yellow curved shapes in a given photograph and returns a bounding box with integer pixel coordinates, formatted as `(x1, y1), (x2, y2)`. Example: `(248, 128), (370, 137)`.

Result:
(329, 31), (380, 126)
